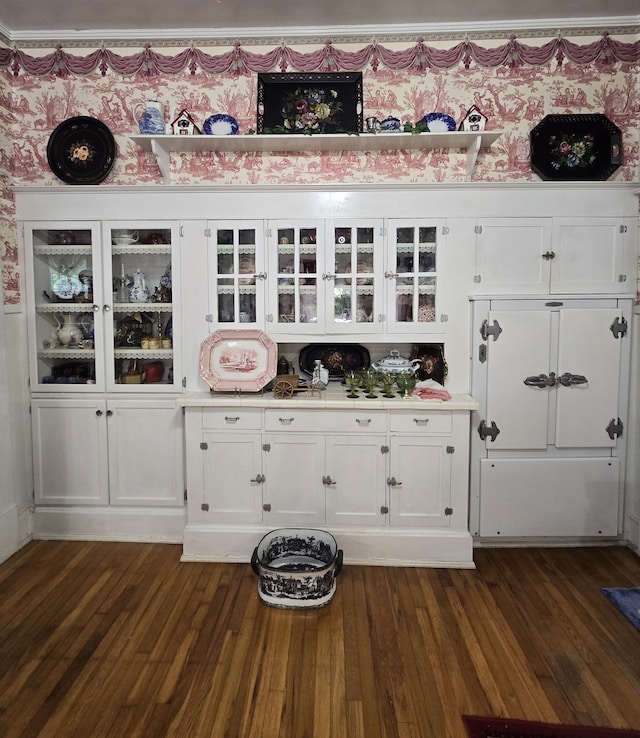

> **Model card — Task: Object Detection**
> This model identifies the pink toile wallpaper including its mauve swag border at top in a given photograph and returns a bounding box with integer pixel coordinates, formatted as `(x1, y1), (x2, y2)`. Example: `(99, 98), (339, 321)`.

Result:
(0, 29), (640, 309)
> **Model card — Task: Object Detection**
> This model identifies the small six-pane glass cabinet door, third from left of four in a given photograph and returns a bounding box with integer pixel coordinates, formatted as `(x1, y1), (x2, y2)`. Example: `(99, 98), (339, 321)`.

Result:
(322, 221), (382, 333)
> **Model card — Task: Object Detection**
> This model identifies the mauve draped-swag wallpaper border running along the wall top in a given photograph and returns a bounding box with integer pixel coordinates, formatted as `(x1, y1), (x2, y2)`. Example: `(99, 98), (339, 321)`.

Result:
(0, 32), (640, 77)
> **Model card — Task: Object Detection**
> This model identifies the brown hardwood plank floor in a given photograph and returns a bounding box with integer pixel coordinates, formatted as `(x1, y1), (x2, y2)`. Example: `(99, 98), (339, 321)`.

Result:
(0, 541), (640, 738)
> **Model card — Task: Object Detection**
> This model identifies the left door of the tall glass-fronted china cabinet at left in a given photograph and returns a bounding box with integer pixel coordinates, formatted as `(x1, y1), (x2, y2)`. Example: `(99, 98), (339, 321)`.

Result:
(25, 221), (104, 392)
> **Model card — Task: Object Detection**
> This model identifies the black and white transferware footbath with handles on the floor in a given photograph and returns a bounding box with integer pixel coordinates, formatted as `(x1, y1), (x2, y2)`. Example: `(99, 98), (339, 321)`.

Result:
(251, 528), (342, 609)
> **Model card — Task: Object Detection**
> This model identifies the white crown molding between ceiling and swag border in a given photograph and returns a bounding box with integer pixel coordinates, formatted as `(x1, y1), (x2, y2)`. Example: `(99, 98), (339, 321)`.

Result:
(0, 14), (640, 47)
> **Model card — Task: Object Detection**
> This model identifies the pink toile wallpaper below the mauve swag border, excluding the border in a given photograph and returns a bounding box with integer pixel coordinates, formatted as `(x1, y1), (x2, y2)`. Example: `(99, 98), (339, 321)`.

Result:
(0, 33), (640, 305)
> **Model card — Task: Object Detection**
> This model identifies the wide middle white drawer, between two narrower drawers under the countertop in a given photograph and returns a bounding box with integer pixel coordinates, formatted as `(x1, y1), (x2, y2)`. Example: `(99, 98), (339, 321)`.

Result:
(265, 408), (387, 433)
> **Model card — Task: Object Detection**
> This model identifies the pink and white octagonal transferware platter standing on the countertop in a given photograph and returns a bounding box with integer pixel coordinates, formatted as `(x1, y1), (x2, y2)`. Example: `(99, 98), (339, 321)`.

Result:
(200, 328), (278, 392)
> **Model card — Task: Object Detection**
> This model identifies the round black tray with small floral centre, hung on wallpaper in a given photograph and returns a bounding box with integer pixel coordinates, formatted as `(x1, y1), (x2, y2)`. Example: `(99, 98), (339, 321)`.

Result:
(47, 115), (116, 184)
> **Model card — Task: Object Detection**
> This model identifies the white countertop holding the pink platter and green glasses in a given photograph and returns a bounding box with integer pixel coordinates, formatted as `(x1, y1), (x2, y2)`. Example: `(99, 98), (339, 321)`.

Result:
(177, 382), (479, 412)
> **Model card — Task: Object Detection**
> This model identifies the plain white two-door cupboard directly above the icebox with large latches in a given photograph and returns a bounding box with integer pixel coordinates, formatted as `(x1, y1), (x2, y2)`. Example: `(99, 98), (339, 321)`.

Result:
(474, 217), (635, 295)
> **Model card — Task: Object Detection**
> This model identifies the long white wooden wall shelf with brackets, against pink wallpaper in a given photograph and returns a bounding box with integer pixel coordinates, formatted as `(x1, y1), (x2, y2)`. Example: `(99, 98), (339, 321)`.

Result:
(131, 131), (502, 184)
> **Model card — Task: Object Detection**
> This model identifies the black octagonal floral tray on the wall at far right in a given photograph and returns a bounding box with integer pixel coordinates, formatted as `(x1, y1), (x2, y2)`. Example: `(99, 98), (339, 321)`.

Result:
(531, 113), (622, 181)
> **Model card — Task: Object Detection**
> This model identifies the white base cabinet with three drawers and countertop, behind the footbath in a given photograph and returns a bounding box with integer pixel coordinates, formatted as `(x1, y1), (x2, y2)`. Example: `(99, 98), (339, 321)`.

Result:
(178, 394), (474, 565)
